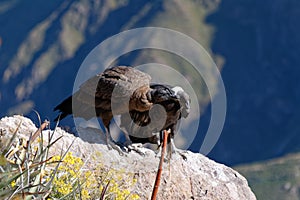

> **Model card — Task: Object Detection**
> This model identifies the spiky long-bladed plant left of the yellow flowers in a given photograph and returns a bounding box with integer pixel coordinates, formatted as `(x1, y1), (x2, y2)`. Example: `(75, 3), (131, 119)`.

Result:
(0, 119), (59, 199)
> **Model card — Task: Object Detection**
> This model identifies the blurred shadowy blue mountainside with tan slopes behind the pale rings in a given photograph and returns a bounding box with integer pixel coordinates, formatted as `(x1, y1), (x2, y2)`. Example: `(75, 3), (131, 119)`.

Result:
(0, 0), (300, 180)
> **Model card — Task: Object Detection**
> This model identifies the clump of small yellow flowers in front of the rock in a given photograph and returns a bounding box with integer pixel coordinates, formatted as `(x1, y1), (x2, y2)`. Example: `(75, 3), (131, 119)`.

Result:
(51, 152), (139, 200)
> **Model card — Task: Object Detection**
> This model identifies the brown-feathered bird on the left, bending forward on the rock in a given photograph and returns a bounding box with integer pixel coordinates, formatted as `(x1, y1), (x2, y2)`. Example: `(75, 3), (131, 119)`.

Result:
(54, 66), (177, 152)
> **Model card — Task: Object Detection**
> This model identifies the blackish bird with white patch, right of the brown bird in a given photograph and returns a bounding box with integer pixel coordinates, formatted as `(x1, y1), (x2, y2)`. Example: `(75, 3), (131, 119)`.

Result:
(120, 84), (191, 157)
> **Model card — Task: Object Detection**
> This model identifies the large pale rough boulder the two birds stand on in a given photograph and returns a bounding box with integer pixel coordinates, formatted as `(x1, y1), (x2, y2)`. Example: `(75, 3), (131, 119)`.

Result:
(0, 115), (256, 200)
